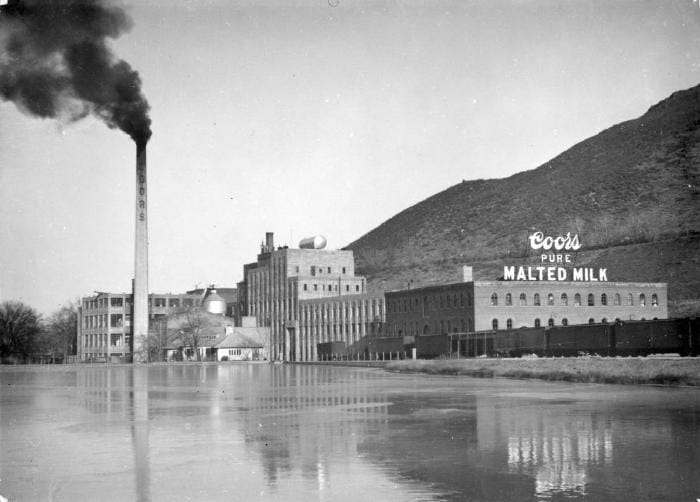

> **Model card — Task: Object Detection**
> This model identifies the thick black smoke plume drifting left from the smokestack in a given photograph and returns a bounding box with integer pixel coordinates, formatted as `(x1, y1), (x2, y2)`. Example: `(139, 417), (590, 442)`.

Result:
(0, 0), (151, 145)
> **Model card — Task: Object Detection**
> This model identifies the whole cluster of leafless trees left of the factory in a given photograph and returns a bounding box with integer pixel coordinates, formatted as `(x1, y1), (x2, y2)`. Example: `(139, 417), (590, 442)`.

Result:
(0, 301), (78, 363)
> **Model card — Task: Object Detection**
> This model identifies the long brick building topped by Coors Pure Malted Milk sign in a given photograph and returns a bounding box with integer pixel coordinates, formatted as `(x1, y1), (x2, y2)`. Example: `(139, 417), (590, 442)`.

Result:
(386, 232), (668, 336)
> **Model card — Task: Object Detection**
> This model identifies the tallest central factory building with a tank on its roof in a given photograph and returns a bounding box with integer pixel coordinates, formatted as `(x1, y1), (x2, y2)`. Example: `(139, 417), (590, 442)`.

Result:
(238, 232), (384, 361)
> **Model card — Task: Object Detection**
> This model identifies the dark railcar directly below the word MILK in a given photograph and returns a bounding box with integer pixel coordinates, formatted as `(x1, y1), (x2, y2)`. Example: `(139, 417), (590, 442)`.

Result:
(547, 324), (614, 356)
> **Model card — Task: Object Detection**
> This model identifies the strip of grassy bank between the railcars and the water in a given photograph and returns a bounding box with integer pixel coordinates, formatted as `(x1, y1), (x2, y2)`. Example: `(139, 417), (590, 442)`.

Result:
(385, 357), (700, 387)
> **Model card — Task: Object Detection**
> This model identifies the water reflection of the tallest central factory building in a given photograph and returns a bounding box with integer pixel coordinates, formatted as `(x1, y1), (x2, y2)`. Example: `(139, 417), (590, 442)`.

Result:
(221, 365), (389, 489)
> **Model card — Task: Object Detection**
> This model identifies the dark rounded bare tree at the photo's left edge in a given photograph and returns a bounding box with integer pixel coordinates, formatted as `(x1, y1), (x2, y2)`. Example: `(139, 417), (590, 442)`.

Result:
(0, 301), (42, 360)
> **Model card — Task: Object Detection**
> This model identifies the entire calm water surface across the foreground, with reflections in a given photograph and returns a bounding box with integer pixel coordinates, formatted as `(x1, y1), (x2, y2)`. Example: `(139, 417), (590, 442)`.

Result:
(0, 363), (700, 502)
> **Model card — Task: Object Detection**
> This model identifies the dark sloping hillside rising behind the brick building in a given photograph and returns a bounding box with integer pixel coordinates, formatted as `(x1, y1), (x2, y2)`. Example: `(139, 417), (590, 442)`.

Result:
(347, 86), (700, 314)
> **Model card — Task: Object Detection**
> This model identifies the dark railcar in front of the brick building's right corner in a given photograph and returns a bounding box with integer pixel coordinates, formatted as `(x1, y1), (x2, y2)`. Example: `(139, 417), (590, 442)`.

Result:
(615, 319), (691, 356)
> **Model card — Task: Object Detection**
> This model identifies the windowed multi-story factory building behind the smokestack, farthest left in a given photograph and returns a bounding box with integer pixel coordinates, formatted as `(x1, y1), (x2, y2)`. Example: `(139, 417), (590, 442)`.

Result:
(78, 293), (203, 361)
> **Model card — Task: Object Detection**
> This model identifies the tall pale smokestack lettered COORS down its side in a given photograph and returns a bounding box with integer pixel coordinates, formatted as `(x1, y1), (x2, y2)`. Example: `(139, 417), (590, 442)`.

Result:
(132, 142), (148, 362)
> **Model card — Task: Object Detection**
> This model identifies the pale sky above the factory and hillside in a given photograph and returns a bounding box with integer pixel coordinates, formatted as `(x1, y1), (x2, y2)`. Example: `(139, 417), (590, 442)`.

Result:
(0, 0), (700, 313)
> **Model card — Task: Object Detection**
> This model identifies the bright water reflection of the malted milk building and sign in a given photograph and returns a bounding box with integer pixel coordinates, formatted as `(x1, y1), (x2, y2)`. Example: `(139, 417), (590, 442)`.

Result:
(478, 402), (613, 495)
